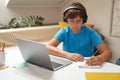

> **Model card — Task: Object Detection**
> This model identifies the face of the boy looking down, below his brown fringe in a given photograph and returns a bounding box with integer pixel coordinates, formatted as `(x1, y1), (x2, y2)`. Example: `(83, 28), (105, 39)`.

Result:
(67, 16), (83, 29)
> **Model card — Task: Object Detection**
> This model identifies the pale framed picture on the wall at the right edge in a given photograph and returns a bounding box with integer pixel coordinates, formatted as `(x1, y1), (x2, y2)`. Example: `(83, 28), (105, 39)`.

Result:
(110, 0), (120, 37)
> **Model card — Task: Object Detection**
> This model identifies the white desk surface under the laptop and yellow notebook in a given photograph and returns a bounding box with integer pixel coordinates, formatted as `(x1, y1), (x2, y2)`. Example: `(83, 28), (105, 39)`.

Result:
(0, 47), (120, 80)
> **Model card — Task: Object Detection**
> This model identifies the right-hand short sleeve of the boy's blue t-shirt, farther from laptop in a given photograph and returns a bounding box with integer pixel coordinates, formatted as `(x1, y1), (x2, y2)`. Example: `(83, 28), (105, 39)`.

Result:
(90, 29), (103, 47)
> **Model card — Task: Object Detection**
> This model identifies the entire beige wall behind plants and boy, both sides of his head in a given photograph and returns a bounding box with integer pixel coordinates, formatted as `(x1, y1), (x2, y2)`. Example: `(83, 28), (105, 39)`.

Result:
(0, 0), (120, 62)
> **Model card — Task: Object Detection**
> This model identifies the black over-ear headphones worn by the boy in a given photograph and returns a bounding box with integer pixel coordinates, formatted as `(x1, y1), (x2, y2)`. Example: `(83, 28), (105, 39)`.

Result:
(63, 6), (88, 23)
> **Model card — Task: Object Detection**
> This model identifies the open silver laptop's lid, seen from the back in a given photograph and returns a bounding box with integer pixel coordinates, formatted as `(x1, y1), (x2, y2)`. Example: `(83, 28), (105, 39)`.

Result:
(16, 38), (53, 70)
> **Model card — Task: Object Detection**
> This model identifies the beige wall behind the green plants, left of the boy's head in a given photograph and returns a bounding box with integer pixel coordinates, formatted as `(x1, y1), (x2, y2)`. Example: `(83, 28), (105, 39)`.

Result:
(0, 0), (60, 24)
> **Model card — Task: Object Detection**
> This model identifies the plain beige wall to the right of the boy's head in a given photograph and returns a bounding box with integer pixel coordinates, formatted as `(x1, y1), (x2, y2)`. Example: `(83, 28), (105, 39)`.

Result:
(61, 0), (120, 62)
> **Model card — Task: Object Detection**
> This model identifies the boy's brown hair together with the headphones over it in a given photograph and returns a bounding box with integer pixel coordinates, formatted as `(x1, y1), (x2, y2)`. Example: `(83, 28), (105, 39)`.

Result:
(63, 2), (88, 24)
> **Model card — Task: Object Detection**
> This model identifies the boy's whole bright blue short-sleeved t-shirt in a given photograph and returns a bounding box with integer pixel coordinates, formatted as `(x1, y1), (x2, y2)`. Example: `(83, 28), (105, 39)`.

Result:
(54, 25), (103, 57)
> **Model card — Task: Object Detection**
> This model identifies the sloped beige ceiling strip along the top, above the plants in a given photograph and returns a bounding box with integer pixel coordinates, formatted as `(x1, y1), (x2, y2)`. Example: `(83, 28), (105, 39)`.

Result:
(5, 0), (69, 7)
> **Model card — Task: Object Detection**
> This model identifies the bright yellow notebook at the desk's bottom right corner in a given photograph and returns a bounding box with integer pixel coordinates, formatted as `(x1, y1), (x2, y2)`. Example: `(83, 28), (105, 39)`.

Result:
(85, 72), (120, 80)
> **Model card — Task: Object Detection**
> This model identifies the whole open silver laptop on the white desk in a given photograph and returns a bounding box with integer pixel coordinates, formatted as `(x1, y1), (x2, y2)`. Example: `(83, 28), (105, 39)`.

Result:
(16, 38), (72, 71)
